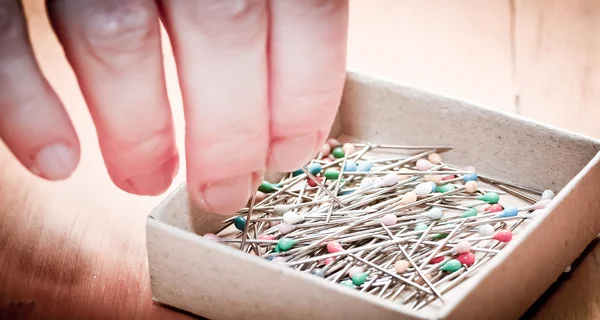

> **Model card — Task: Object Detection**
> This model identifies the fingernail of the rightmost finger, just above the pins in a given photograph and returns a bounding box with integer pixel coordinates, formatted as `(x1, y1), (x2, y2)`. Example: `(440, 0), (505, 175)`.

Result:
(269, 132), (319, 172)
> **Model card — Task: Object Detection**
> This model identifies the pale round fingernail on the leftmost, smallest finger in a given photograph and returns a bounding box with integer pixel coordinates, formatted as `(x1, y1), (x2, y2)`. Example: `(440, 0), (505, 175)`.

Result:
(30, 143), (79, 180)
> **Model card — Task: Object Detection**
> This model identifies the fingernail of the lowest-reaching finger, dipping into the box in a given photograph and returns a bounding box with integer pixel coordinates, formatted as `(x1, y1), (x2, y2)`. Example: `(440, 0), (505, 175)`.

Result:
(199, 173), (253, 214)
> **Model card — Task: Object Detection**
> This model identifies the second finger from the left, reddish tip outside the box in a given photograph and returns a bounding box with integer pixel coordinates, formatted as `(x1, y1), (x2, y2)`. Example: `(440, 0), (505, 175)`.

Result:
(47, 0), (179, 195)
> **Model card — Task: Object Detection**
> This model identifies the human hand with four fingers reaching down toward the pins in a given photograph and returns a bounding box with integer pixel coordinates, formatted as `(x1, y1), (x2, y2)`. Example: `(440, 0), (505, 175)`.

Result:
(0, 0), (348, 213)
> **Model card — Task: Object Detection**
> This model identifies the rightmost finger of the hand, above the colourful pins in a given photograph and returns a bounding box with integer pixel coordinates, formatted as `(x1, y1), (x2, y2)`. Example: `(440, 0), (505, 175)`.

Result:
(267, 0), (348, 171)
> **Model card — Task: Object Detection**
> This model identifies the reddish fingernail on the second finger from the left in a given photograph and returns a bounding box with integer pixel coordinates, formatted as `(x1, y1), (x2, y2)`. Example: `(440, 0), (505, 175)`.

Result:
(123, 154), (179, 196)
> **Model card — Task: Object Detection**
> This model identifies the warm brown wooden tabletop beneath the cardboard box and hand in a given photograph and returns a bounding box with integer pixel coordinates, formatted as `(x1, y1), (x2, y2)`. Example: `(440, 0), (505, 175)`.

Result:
(0, 0), (600, 319)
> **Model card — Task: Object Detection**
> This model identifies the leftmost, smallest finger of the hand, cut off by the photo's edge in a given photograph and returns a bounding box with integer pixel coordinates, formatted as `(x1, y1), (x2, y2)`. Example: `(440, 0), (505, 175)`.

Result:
(0, 0), (79, 180)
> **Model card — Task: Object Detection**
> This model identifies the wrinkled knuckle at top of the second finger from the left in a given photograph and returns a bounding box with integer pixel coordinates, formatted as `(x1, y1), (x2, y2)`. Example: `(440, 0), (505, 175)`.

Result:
(83, 1), (159, 53)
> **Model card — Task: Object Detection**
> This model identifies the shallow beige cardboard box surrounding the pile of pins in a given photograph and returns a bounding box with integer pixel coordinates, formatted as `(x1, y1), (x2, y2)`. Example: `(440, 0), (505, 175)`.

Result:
(147, 72), (600, 319)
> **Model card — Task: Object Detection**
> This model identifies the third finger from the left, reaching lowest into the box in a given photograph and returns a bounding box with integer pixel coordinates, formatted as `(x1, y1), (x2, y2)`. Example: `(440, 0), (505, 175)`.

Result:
(161, 0), (269, 213)
